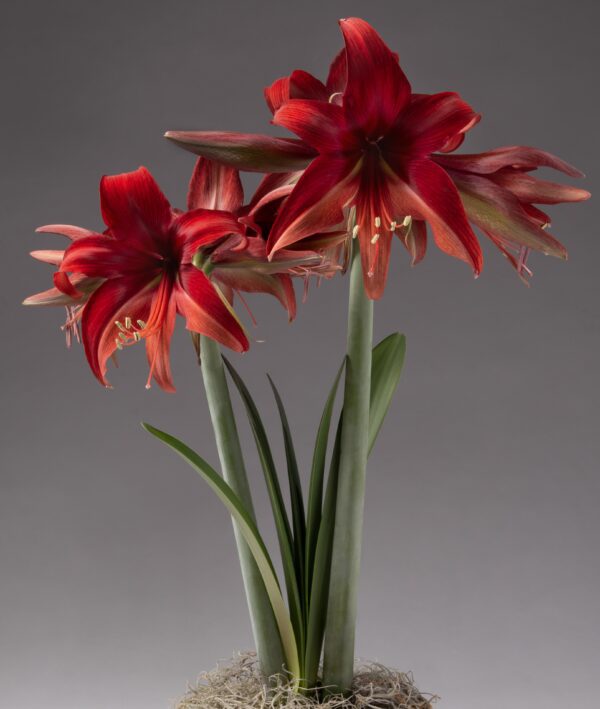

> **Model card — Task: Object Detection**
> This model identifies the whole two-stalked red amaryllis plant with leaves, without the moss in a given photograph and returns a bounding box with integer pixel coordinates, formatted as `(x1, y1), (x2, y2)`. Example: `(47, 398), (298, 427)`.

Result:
(25, 18), (589, 697)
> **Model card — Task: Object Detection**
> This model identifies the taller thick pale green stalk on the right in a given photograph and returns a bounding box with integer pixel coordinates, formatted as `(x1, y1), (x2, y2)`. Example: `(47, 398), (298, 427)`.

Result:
(323, 240), (373, 693)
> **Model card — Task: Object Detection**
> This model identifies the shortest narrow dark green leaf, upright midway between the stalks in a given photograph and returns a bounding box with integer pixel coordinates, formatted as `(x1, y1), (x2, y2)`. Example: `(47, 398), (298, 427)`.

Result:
(267, 374), (306, 618)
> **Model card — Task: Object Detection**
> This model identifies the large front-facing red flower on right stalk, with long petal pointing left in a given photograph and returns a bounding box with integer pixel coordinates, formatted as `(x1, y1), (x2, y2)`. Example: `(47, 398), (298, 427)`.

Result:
(167, 18), (482, 298)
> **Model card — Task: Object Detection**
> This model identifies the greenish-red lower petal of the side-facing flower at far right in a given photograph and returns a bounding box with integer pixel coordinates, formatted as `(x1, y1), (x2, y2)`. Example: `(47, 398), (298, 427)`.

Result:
(452, 172), (566, 258)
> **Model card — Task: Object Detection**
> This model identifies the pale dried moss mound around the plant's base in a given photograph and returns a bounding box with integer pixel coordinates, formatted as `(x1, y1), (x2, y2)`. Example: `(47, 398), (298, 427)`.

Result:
(176, 653), (437, 709)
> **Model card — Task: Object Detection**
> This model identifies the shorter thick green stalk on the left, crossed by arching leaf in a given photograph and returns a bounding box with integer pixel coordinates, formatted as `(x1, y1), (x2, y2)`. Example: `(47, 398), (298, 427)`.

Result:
(201, 336), (285, 677)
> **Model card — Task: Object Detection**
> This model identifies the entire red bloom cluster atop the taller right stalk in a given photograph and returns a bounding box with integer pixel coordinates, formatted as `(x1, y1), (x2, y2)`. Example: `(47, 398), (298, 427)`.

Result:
(166, 18), (589, 298)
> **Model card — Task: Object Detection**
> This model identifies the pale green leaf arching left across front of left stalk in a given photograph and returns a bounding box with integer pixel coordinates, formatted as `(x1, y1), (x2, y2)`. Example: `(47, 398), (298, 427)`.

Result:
(142, 423), (301, 678)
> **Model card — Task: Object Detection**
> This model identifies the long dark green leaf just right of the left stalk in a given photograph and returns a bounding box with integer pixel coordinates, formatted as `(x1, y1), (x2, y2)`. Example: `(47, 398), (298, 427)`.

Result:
(223, 357), (304, 660)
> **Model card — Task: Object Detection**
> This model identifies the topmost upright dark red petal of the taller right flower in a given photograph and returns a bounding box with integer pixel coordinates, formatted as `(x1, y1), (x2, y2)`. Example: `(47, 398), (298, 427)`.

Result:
(340, 17), (410, 139)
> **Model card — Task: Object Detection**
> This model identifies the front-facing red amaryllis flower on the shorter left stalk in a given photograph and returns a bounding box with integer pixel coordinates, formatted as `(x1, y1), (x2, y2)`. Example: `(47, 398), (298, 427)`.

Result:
(36, 168), (248, 391)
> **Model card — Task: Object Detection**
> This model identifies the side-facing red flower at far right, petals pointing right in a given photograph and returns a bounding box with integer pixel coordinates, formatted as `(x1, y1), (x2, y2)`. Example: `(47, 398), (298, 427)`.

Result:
(434, 146), (590, 282)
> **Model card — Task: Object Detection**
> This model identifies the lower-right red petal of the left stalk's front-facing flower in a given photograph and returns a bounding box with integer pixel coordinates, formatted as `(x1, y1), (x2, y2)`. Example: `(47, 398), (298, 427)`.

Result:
(175, 266), (250, 352)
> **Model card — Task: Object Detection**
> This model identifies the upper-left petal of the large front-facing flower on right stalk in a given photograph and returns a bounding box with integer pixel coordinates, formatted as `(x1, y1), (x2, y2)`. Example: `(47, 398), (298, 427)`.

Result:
(272, 99), (358, 153)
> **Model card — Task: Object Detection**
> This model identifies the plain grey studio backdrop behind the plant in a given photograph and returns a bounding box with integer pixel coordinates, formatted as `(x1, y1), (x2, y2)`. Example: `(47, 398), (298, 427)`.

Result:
(0, 0), (600, 709)
